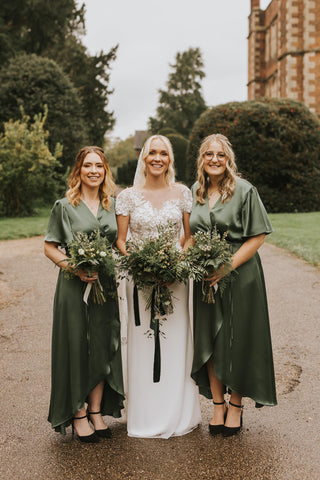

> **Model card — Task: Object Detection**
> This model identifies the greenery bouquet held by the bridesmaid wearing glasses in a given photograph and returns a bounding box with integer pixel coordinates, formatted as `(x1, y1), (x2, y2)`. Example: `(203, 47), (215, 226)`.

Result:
(182, 227), (232, 303)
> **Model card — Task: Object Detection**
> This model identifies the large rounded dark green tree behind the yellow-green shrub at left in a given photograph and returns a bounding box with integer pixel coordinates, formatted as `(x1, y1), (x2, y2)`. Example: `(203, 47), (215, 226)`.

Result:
(0, 54), (88, 168)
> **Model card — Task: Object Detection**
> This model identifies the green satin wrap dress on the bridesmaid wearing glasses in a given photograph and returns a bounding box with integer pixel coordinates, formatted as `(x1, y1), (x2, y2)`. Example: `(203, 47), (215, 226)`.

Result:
(190, 179), (277, 407)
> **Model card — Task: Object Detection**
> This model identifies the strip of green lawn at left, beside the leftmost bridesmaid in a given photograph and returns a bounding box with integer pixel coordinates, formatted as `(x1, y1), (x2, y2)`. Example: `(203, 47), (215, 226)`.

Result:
(0, 207), (51, 240)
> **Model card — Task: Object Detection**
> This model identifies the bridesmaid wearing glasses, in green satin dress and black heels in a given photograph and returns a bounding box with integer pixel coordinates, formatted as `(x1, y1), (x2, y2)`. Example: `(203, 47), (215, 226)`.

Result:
(190, 134), (277, 436)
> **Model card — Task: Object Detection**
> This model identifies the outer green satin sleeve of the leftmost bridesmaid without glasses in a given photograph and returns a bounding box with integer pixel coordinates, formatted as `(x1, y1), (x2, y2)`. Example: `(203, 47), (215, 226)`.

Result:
(45, 200), (73, 247)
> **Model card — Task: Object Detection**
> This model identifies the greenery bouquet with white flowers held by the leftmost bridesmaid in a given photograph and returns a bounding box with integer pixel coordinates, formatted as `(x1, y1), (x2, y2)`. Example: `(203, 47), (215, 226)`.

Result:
(60, 230), (116, 305)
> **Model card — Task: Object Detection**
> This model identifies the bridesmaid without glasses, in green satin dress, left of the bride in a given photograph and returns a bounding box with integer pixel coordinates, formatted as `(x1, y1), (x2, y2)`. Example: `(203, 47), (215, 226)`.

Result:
(45, 147), (124, 443)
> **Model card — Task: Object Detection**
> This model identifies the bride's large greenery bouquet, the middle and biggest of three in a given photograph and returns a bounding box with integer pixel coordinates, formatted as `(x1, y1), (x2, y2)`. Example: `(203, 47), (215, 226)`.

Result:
(118, 222), (188, 320)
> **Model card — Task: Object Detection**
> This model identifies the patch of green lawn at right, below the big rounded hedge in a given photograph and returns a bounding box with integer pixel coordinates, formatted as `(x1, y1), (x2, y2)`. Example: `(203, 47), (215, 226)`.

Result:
(266, 212), (320, 266)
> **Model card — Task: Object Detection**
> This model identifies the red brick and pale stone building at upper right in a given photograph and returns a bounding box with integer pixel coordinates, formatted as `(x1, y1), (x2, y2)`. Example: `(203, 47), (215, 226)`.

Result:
(248, 0), (320, 115)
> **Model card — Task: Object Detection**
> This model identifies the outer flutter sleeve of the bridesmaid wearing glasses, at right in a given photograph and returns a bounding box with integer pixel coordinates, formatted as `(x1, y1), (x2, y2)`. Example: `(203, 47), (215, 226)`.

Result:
(242, 187), (273, 237)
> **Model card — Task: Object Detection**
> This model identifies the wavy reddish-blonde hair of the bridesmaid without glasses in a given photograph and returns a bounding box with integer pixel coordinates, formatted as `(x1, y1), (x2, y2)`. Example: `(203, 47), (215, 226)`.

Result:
(66, 145), (115, 210)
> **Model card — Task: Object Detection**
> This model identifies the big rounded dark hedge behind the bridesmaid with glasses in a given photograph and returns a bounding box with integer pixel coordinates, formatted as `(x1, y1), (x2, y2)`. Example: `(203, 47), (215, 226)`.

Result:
(187, 99), (320, 212)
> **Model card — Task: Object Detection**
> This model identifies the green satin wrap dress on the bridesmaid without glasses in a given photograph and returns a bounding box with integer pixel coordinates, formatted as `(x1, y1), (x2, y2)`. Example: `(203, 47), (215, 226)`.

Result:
(45, 198), (124, 434)
